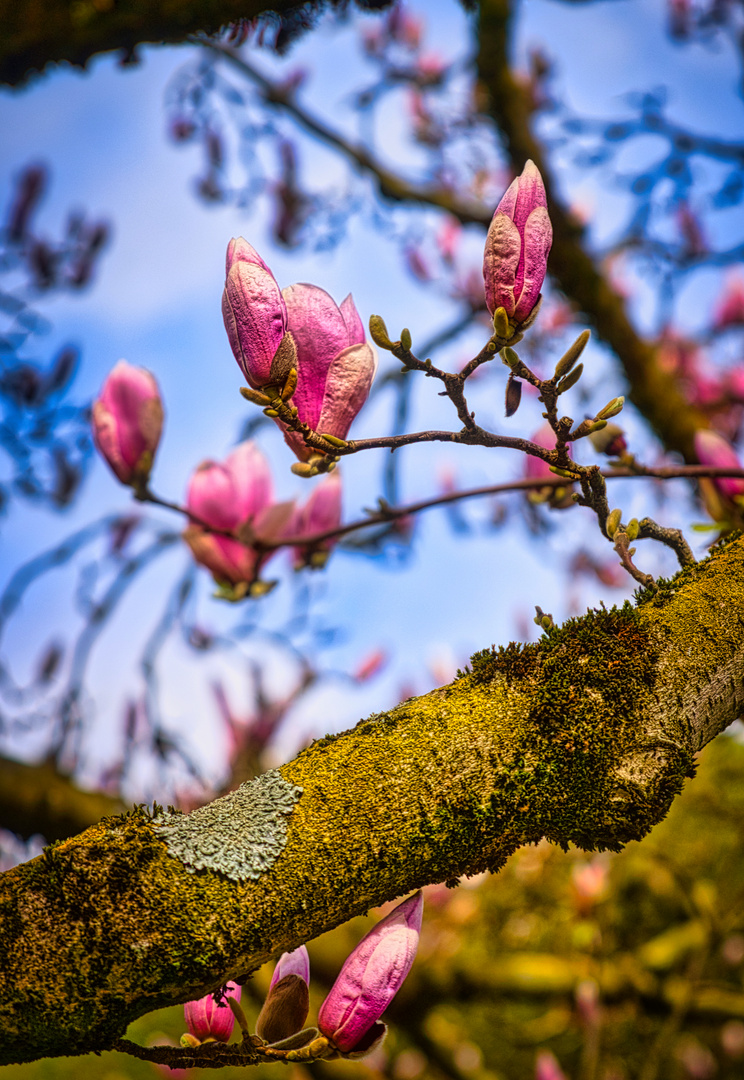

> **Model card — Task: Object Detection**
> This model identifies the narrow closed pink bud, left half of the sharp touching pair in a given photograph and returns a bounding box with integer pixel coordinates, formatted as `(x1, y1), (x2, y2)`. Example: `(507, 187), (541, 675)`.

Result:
(222, 237), (287, 390)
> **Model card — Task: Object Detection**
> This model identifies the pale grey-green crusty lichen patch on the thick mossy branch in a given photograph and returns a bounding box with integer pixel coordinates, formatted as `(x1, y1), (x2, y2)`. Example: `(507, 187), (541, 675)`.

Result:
(152, 769), (302, 881)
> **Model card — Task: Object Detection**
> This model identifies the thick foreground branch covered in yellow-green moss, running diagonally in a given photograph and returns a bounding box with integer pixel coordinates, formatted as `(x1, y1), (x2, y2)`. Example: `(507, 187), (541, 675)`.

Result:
(0, 539), (744, 1063)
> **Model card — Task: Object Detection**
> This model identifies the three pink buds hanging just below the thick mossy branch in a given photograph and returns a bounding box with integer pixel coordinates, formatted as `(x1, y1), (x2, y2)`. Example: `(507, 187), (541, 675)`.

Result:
(181, 892), (423, 1061)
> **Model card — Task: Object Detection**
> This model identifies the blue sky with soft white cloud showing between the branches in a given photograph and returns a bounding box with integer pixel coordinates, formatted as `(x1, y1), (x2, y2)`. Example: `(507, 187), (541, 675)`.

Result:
(0, 0), (742, 794)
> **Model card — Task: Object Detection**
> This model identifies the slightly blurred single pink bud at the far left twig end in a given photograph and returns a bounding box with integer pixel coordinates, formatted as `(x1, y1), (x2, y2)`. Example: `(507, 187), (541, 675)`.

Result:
(92, 360), (163, 484)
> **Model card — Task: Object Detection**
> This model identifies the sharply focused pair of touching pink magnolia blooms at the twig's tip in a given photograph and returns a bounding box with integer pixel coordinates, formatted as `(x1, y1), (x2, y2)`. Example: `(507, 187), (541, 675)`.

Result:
(222, 238), (377, 476)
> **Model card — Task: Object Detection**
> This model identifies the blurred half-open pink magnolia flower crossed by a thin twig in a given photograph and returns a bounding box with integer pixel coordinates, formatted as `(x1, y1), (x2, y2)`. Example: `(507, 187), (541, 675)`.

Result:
(184, 442), (294, 585)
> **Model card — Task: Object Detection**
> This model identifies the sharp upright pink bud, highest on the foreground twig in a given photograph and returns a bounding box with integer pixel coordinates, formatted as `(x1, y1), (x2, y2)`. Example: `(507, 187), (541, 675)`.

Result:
(483, 161), (553, 324)
